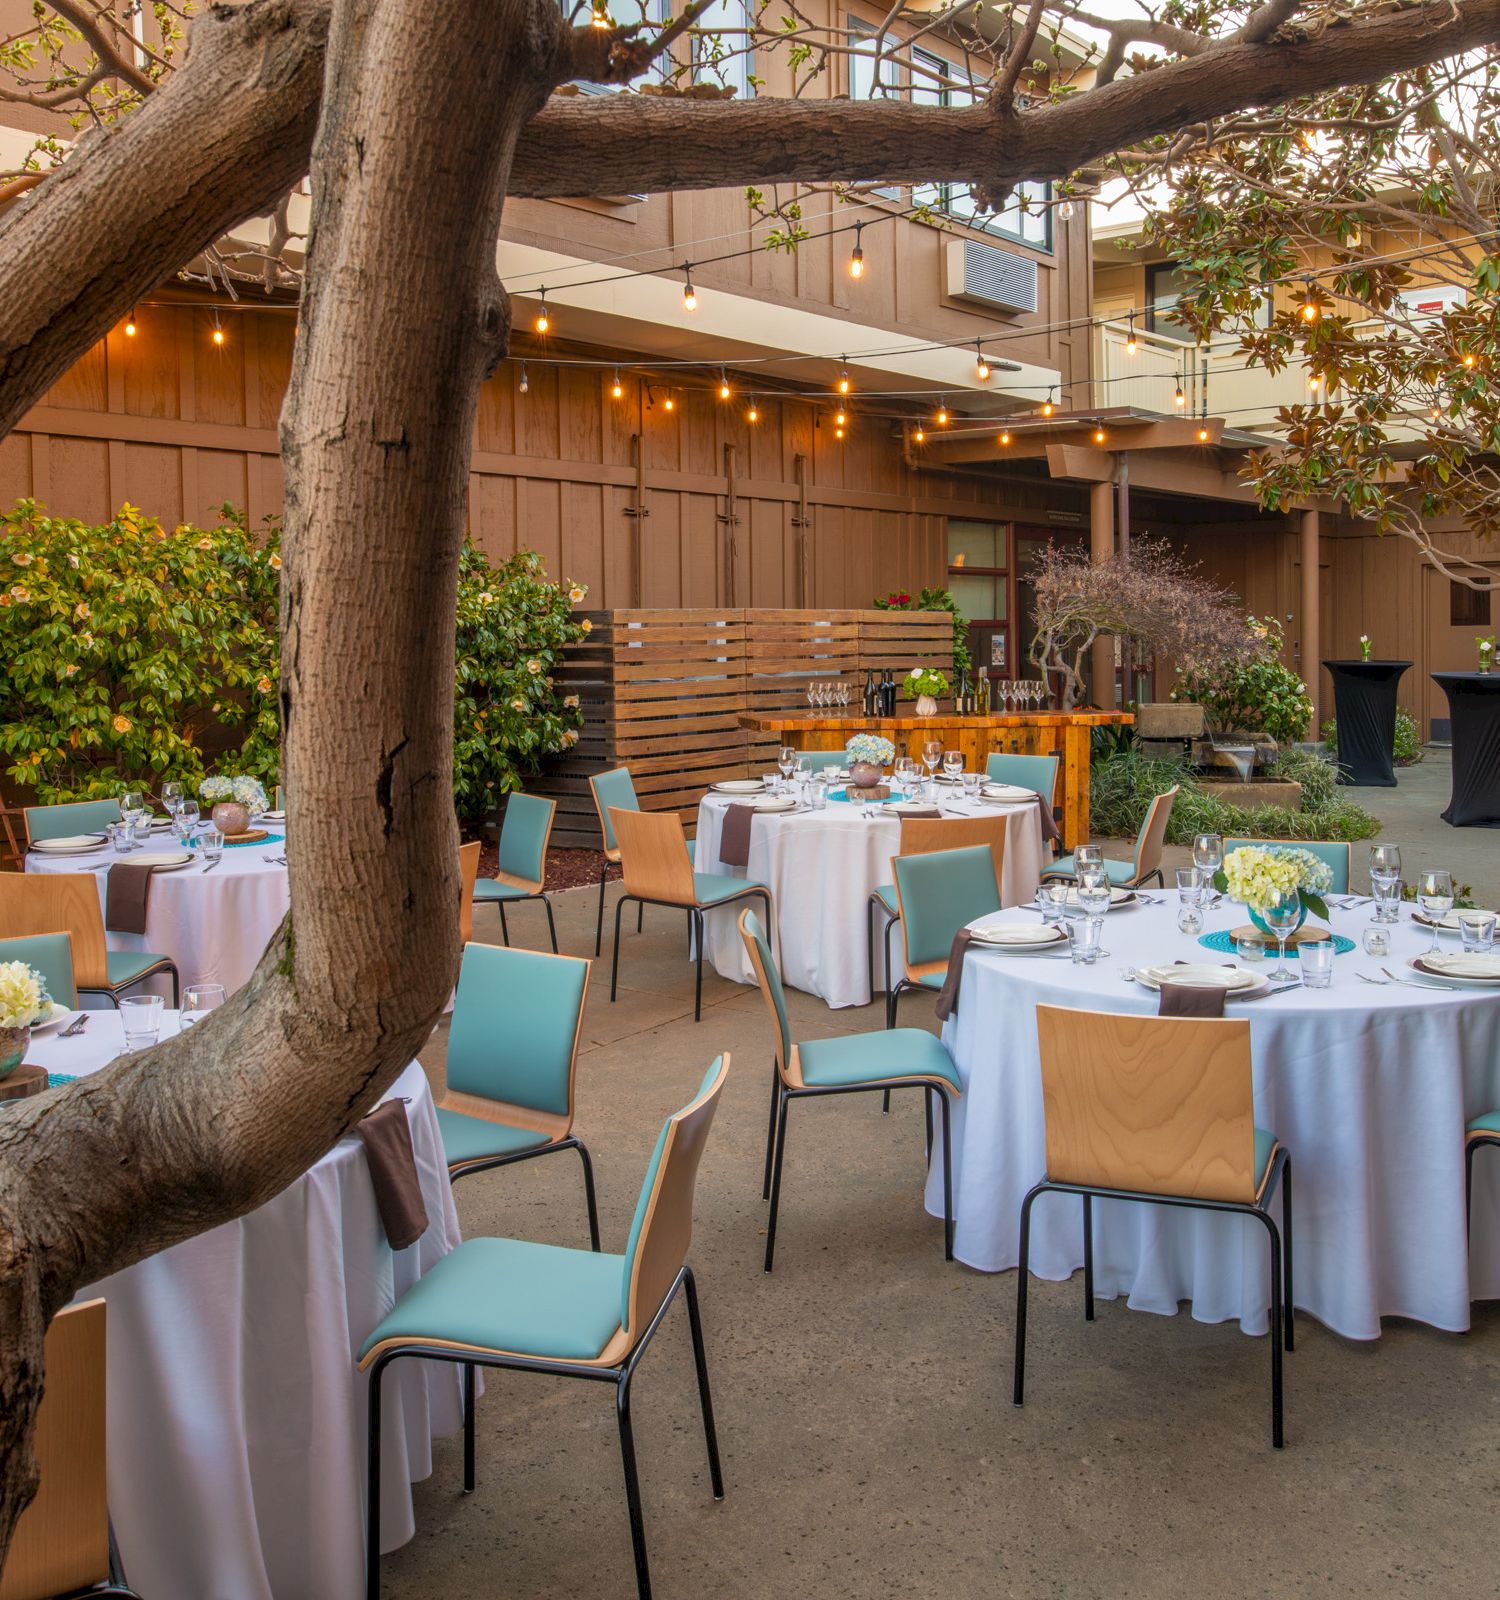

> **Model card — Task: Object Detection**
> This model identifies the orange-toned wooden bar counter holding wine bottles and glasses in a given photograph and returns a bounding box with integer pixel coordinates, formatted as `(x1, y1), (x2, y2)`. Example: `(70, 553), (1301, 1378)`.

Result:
(740, 710), (1135, 850)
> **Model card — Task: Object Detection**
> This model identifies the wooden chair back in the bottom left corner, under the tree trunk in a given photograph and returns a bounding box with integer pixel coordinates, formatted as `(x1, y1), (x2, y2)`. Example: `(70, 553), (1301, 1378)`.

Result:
(0, 1299), (109, 1600)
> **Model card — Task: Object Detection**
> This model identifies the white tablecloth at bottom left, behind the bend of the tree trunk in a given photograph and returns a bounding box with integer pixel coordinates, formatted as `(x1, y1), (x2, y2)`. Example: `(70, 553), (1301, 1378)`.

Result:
(27, 1013), (462, 1600)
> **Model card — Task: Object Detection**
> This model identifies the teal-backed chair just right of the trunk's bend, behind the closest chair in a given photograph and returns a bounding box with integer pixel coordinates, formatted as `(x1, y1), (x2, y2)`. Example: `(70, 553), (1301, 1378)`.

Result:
(438, 944), (600, 1250)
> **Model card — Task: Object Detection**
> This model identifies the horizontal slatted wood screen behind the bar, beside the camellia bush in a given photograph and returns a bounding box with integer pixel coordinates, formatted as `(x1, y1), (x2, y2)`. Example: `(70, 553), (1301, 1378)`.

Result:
(543, 608), (953, 848)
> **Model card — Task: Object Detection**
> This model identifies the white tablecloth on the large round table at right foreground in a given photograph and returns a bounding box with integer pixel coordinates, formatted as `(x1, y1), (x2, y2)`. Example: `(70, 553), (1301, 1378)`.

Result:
(928, 894), (1500, 1339)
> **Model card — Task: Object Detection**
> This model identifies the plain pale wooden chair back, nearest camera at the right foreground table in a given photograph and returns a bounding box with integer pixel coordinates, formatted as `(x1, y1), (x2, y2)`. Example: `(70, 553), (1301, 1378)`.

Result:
(1036, 1005), (1257, 1205)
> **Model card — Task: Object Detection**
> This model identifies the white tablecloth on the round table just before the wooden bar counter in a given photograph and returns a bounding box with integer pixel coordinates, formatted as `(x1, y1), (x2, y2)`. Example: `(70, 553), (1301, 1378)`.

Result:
(696, 786), (1043, 1006)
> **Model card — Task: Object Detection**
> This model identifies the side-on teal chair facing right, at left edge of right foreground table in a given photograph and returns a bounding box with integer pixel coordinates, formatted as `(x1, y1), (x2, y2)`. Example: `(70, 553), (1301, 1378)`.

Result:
(739, 921), (959, 1272)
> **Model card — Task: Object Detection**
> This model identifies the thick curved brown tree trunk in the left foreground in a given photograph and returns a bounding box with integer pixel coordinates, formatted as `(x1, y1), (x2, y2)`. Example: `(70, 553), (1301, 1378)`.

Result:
(0, 0), (568, 1560)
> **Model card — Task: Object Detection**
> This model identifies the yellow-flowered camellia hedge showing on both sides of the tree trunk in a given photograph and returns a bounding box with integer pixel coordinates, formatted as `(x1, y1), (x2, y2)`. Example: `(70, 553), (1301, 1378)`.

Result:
(0, 501), (590, 824)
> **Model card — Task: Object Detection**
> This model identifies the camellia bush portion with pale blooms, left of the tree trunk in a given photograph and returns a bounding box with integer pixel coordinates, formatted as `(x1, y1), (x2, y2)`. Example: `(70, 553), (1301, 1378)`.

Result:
(0, 501), (281, 805)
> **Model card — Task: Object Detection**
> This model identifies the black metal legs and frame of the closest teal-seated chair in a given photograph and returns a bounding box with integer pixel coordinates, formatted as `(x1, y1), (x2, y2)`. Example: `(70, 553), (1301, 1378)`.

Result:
(365, 1266), (724, 1600)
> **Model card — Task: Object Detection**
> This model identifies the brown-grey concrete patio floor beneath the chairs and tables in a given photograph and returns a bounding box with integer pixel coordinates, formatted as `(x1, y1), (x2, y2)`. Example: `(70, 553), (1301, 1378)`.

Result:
(384, 752), (1500, 1600)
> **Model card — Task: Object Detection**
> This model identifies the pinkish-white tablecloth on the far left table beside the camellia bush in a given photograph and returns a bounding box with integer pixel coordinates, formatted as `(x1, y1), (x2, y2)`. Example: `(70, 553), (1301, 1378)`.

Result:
(26, 824), (291, 994)
